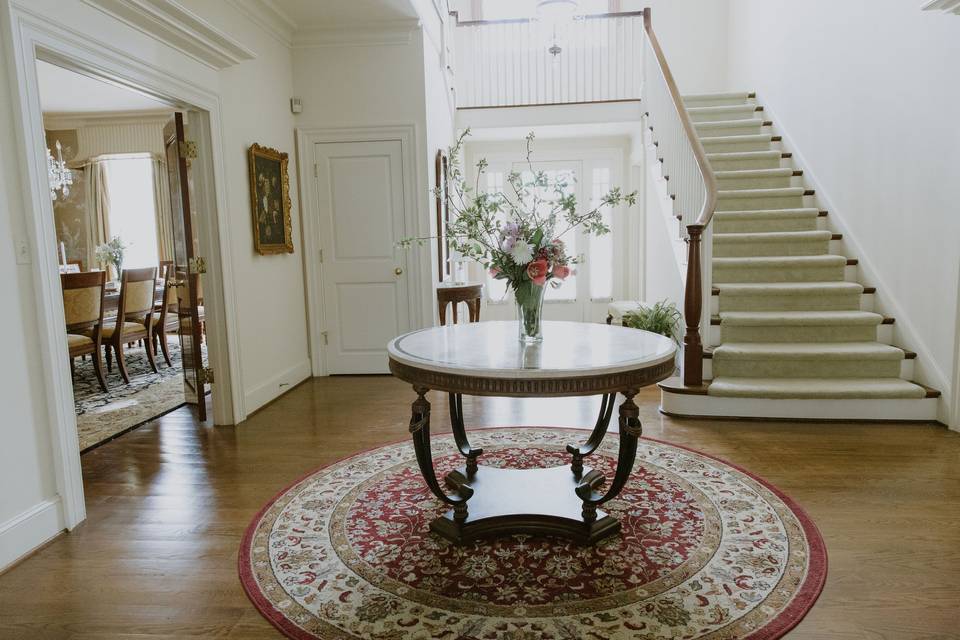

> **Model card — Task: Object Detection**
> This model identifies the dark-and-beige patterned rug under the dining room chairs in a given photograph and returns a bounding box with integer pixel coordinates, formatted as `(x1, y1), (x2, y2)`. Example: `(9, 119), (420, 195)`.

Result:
(73, 336), (206, 452)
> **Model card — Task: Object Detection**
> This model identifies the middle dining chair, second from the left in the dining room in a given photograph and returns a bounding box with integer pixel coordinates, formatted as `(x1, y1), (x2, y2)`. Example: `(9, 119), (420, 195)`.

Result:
(102, 267), (160, 384)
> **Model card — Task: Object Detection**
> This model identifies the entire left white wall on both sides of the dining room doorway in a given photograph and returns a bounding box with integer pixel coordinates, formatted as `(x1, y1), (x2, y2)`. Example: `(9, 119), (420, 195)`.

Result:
(0, 0), (309, 568)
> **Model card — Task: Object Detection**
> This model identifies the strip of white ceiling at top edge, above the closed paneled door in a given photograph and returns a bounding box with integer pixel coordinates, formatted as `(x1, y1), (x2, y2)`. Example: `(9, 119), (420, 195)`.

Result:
(271, 0), (417, 27)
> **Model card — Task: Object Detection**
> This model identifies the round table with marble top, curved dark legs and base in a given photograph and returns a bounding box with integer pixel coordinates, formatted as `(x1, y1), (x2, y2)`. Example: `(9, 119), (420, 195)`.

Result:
(387, 322), (676, 544)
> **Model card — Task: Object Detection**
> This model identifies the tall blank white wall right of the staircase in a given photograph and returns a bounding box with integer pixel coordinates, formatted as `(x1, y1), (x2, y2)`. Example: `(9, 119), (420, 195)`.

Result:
(729, 0), (960, 419)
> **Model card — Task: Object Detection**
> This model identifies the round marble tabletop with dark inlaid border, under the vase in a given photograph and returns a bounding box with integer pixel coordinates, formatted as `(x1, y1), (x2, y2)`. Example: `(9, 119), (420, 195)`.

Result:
(387, 321), (676, 379)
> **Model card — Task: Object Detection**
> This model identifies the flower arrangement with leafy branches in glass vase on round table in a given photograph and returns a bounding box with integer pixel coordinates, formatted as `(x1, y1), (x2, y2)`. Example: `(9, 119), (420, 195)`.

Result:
(401, 129), (636, 342)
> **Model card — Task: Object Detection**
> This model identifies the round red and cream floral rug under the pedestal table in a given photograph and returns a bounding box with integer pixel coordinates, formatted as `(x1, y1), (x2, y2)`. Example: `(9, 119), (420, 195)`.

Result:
(239, 428), (827, 640)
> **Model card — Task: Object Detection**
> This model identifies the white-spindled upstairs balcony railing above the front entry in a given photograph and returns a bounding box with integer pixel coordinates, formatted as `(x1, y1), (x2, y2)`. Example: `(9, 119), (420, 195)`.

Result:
(454, 12), (643, 108)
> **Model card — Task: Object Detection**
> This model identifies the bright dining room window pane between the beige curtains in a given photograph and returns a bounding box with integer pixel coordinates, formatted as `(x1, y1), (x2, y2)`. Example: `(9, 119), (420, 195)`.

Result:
(107, 158), (159, 269)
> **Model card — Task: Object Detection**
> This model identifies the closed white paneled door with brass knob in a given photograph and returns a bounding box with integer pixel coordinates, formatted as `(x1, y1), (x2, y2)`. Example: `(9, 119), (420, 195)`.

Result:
(315, 140), (411, 374)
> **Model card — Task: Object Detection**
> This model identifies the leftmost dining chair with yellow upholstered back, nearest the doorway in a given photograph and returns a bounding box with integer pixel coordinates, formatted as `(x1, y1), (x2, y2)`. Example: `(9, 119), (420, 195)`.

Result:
(60, 271), (107, 391)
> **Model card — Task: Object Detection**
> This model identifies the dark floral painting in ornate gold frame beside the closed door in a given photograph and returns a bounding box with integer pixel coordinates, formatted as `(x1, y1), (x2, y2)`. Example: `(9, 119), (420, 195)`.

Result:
(249, 144), (293, 255)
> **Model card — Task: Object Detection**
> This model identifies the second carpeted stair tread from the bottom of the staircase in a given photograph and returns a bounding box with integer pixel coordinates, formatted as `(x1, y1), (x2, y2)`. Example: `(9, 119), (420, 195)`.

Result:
(713, 342), (906, 363)
